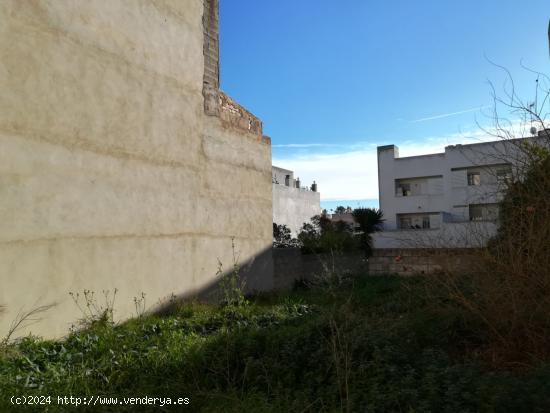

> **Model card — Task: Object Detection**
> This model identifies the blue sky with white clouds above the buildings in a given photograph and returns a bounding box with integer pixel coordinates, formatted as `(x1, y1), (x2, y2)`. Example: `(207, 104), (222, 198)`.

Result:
(220, 0), (550, 206)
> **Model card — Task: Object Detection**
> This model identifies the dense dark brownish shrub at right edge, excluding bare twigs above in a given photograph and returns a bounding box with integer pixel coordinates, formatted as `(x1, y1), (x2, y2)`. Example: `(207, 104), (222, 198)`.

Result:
(438, 141), (550, 368)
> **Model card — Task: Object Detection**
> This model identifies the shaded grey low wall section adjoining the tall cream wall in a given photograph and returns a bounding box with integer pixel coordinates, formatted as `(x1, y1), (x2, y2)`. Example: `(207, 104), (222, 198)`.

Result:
(273, 248), (367, 290)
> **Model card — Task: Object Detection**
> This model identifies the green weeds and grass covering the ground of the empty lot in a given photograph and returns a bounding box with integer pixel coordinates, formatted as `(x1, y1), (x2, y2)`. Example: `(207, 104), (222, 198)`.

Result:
(0, 277), (550, 413)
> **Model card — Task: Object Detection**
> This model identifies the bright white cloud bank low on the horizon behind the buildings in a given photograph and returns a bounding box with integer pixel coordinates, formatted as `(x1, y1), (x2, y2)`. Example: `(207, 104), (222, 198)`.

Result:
(273, 131), (506, 200)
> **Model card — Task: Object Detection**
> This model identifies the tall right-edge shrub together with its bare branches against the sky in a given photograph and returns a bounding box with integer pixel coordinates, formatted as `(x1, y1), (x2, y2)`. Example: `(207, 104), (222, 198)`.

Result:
(435, 68), (550, 370)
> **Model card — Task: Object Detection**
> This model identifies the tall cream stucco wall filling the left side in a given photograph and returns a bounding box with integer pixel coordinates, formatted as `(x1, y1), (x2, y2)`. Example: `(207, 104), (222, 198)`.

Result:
(0, 0), (272, 336)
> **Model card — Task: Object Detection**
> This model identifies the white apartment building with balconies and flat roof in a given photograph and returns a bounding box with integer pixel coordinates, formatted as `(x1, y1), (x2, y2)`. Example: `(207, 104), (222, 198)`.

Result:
(373, 140), (519, 248)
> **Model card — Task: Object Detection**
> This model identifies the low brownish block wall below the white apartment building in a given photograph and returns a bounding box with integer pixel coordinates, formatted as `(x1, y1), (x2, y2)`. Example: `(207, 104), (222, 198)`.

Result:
(369, 248), (479, 275)
